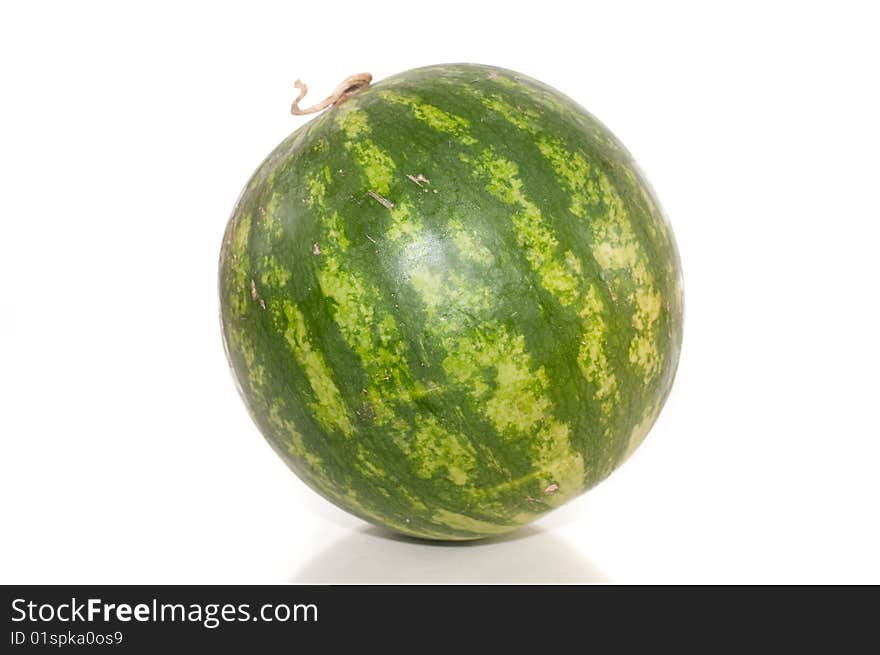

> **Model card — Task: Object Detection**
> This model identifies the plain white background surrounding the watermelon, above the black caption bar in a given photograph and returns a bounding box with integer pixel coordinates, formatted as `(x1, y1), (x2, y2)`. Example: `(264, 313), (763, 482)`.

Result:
(0, 0), (880, 583)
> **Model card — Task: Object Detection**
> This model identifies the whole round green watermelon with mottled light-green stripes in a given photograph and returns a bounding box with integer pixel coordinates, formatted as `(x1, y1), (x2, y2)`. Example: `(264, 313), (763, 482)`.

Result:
(219, 64), (682, 540)
